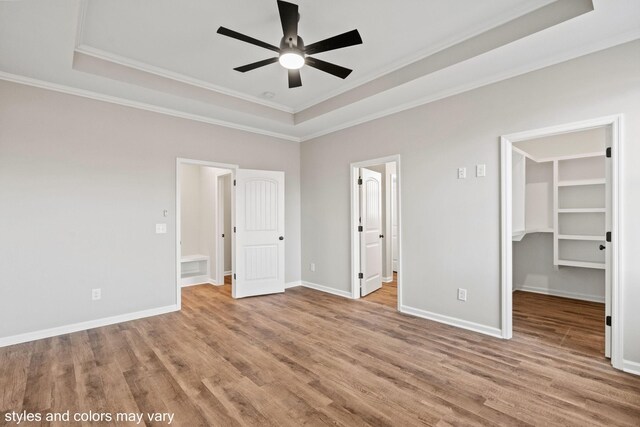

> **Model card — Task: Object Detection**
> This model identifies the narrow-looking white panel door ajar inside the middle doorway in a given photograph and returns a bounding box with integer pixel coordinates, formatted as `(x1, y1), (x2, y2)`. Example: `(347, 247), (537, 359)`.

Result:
(360, 168), (382, 296)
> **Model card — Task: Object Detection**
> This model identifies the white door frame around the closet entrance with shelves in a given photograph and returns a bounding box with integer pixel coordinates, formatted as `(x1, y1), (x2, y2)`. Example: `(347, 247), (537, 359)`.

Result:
(500, 114), (624, 369)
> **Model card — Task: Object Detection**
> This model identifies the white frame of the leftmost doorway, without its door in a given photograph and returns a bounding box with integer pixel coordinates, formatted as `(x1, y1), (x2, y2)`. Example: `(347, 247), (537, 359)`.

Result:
(175, 157), (238, 310)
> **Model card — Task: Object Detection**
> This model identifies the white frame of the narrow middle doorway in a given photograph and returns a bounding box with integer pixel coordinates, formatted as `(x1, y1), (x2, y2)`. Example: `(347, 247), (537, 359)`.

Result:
(349, 154), (403, 311)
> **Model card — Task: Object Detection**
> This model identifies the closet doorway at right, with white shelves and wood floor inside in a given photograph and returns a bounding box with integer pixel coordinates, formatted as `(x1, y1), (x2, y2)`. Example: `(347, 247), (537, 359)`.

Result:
(502, 116), (622, 368)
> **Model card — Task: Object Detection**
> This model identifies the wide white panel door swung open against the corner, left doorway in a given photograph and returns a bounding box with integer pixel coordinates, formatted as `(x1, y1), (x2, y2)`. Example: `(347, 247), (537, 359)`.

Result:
(232, 169), (284, 298)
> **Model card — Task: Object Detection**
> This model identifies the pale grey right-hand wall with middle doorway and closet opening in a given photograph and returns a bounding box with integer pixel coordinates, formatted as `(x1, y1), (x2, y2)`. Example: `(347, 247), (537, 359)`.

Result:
(301, 41), (640, 363)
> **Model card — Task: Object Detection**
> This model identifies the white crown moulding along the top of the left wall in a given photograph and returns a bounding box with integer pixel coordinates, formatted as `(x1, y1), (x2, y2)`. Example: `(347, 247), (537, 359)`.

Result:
(0, 71), (301, 142)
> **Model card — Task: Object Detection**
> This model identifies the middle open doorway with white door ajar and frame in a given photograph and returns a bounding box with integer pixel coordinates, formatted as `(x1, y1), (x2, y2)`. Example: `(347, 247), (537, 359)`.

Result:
(351, 156), (401, 309)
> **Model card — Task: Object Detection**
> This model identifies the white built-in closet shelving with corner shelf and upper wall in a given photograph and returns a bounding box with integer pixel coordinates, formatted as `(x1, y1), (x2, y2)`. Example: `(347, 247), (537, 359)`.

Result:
(512, 148), (606, 269)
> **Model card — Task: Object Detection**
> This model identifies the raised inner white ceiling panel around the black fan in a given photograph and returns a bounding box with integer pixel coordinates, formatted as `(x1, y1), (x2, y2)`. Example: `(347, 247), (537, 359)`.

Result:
(80, 0), (553, 111)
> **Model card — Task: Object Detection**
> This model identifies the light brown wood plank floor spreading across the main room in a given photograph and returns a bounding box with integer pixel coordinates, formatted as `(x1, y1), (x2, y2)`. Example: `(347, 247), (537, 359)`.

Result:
(0, 286), (640, 427)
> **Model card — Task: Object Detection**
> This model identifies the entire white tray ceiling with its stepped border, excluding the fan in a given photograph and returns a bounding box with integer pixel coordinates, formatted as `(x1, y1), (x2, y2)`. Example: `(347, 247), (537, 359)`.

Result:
(0, 0), (640, 141)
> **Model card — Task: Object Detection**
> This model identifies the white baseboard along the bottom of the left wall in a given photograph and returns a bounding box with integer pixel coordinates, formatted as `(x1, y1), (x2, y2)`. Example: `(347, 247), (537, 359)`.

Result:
(0, 304), (180, 347)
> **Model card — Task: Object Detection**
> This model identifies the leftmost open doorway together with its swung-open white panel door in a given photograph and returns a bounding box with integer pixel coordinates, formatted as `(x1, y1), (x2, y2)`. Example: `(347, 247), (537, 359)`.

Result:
(176, 158), (285, 307)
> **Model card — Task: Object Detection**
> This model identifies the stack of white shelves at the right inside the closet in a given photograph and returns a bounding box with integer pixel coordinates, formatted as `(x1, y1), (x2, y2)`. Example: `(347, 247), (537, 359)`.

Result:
(553, 152), (606, 269)
